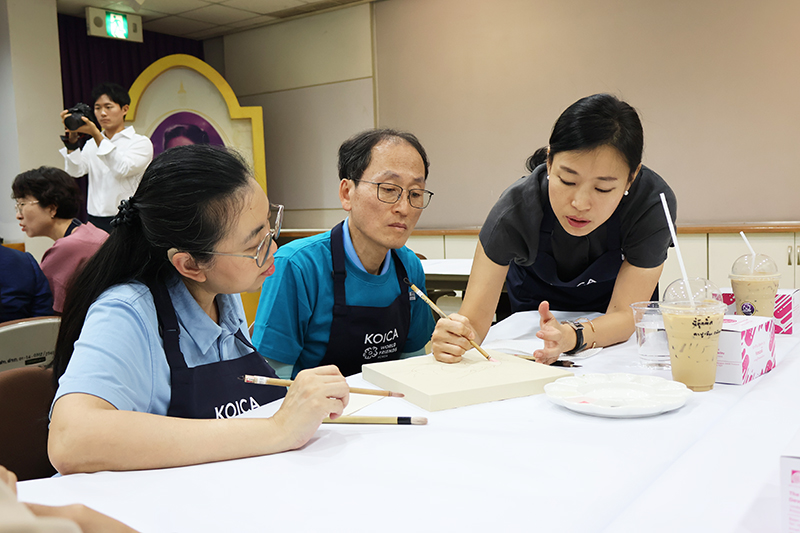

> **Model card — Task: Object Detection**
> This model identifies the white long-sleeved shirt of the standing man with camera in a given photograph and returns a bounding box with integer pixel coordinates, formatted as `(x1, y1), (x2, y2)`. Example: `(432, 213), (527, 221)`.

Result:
(60, 126), (153, 217)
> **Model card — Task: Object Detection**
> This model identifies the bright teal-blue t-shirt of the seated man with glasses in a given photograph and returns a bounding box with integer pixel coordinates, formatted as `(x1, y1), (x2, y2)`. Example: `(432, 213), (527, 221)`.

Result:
(253, 222), (435, 377)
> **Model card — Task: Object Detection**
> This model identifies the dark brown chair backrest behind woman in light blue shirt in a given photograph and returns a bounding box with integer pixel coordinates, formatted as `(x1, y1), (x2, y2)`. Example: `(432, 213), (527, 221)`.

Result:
(0, 366), (56, 481)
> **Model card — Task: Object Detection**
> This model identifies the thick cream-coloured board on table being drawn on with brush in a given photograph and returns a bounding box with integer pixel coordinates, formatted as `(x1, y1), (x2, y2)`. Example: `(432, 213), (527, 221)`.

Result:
(362, 349), (572, 411)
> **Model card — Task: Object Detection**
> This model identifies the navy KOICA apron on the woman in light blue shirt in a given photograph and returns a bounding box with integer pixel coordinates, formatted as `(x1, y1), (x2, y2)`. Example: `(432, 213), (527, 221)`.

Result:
(148, 282), (286, 418)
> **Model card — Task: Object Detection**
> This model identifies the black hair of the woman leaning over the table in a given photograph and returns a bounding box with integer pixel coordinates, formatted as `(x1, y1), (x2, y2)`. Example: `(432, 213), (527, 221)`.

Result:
(528, 94), (644, 181)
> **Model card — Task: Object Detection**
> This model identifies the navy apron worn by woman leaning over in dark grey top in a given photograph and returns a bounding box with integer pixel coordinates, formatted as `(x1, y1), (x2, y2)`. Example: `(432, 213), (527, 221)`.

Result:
(506, 198), (625, 313)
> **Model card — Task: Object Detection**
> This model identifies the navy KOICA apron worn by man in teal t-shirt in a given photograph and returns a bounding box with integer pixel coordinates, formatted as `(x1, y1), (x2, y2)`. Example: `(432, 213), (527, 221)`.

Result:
(320, 222), (411, 376)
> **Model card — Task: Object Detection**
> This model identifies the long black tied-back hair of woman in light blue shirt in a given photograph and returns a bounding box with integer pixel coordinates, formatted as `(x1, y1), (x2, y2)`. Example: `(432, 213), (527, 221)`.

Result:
(53, 144), (252, 384)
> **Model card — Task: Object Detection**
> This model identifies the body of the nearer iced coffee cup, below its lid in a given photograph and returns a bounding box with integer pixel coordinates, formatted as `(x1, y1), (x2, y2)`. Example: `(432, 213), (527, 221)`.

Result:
(661, 300), (726, 392)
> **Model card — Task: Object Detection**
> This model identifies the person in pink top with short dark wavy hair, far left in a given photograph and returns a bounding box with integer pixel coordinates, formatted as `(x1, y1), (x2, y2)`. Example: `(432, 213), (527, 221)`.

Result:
(11, 167), (108, 314)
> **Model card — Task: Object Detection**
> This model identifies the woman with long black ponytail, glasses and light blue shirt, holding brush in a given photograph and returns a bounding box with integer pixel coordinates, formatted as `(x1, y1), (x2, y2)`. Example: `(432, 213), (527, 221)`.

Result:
(49, 145), (349, 473)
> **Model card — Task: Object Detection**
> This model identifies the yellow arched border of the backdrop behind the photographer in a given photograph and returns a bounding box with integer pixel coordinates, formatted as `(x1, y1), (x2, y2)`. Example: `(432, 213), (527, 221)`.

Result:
(125, 54), (267, 192)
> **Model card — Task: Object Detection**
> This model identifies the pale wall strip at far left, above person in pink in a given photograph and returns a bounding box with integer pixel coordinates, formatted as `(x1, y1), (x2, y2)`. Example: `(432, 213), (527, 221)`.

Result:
(0, 0), (64, 258)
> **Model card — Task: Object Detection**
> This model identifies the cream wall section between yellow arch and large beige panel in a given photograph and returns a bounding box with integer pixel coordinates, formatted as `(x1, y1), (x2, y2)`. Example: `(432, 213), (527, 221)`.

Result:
(222, 4), (375, 228)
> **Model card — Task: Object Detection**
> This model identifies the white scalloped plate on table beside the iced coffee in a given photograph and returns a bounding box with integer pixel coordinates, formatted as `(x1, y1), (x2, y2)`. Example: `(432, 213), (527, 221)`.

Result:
(544, 374), (692, 418)
